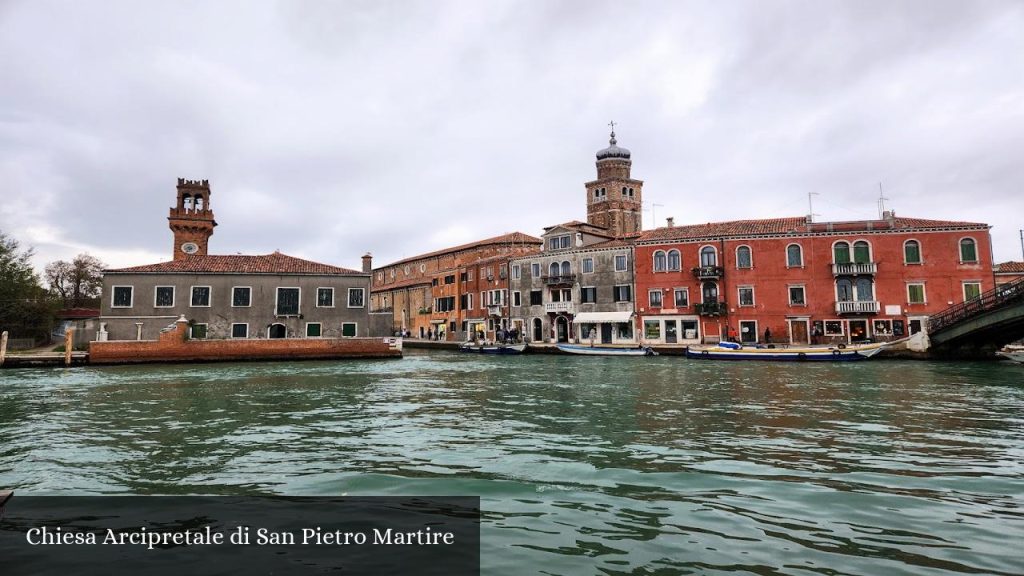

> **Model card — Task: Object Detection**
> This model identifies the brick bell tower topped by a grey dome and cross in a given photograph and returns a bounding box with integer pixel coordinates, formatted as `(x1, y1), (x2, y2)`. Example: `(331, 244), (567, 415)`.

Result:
(586, 122), (643, 237)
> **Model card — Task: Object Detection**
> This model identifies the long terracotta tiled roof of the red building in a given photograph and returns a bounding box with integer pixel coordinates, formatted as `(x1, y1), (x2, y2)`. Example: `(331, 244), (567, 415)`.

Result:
(637, 216), (988, 243)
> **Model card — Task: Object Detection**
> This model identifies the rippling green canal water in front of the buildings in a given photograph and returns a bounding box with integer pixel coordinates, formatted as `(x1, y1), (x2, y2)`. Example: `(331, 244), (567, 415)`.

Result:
(0, 351), (1024, 575)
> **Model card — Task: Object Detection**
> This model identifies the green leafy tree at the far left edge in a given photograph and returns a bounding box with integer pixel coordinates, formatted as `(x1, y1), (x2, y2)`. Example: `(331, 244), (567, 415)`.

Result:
(0, 231), (53, 339)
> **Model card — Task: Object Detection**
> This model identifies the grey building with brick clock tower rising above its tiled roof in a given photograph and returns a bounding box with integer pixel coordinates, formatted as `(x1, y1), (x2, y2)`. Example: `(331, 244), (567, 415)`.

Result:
(99, 179), (382, 340)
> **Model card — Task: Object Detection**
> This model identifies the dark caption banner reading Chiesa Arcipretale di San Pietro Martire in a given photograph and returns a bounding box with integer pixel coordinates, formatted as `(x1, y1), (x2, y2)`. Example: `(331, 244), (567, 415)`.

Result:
(0, 496), (480, 576)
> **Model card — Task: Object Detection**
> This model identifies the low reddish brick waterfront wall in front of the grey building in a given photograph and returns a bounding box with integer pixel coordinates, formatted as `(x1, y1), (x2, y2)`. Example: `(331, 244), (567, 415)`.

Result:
(89, 322), (401, 364)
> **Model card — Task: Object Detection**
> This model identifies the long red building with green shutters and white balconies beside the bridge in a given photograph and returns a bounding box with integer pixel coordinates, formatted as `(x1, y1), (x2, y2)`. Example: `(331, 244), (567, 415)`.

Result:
(635, 212), (993, 343)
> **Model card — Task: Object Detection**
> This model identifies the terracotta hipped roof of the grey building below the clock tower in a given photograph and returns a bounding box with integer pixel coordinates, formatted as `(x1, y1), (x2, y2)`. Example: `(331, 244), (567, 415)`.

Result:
(103, 252), (365, 276)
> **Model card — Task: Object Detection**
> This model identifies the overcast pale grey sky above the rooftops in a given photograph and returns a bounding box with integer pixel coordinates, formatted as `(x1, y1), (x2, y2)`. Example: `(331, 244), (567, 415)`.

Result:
(0, 0), (1024, 270)
